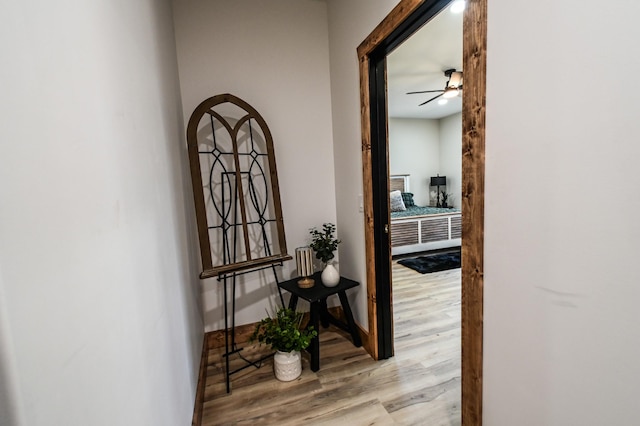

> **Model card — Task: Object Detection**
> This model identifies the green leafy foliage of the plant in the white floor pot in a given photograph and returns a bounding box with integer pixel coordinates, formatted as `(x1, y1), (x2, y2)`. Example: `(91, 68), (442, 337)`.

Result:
(250, 308), (318, 352)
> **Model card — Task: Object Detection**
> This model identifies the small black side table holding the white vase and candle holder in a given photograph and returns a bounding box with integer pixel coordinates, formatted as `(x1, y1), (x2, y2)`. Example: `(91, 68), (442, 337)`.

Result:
(278, 272), (362, 371)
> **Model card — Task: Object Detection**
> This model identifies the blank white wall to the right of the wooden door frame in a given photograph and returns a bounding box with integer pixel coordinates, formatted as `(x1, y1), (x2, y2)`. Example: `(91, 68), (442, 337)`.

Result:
(484, 0), (640, 425)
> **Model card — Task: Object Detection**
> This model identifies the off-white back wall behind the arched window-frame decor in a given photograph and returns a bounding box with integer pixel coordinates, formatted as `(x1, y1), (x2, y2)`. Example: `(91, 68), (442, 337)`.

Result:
(174, 0), (338, 330)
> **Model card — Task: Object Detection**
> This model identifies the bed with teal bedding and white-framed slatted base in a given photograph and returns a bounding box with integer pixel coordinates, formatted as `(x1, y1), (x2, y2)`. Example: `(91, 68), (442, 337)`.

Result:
(390, 175), (462, 256)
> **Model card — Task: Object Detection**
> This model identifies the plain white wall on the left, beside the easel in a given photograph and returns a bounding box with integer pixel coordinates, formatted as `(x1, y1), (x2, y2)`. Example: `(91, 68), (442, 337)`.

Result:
(0, 0), (203, 426)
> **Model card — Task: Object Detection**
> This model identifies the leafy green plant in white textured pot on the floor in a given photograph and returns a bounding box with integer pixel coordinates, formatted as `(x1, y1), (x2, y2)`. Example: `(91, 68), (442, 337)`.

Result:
(250, 308), (318, 382)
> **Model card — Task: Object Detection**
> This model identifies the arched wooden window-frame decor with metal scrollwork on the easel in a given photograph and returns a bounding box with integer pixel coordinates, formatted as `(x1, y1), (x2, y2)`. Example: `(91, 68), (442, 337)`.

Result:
(187, 93), (291, 278)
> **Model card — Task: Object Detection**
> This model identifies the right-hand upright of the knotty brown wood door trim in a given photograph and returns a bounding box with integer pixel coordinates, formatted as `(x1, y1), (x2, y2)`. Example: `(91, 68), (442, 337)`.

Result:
(462, 0), (487, 425)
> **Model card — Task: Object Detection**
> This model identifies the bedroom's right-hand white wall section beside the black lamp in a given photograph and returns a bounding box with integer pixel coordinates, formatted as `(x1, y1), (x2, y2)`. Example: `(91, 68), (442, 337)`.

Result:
(438, 113), (462, 208)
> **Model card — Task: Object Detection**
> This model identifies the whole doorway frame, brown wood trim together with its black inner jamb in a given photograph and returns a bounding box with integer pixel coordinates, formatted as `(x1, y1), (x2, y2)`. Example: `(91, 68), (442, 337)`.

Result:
(358, 0), (487, 425)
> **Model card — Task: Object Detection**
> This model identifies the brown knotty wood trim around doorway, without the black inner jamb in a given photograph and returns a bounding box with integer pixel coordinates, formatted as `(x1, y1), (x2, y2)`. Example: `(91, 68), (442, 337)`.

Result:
(357, 0), (487, 425)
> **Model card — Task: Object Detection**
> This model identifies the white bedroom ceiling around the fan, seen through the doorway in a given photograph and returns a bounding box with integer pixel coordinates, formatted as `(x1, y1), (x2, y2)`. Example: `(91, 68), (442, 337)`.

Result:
(387, 3), (463, 119)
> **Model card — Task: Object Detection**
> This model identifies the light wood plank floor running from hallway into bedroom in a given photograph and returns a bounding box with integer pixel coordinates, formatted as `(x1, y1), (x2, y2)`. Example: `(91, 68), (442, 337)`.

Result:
(202, 262), (461, 426)
